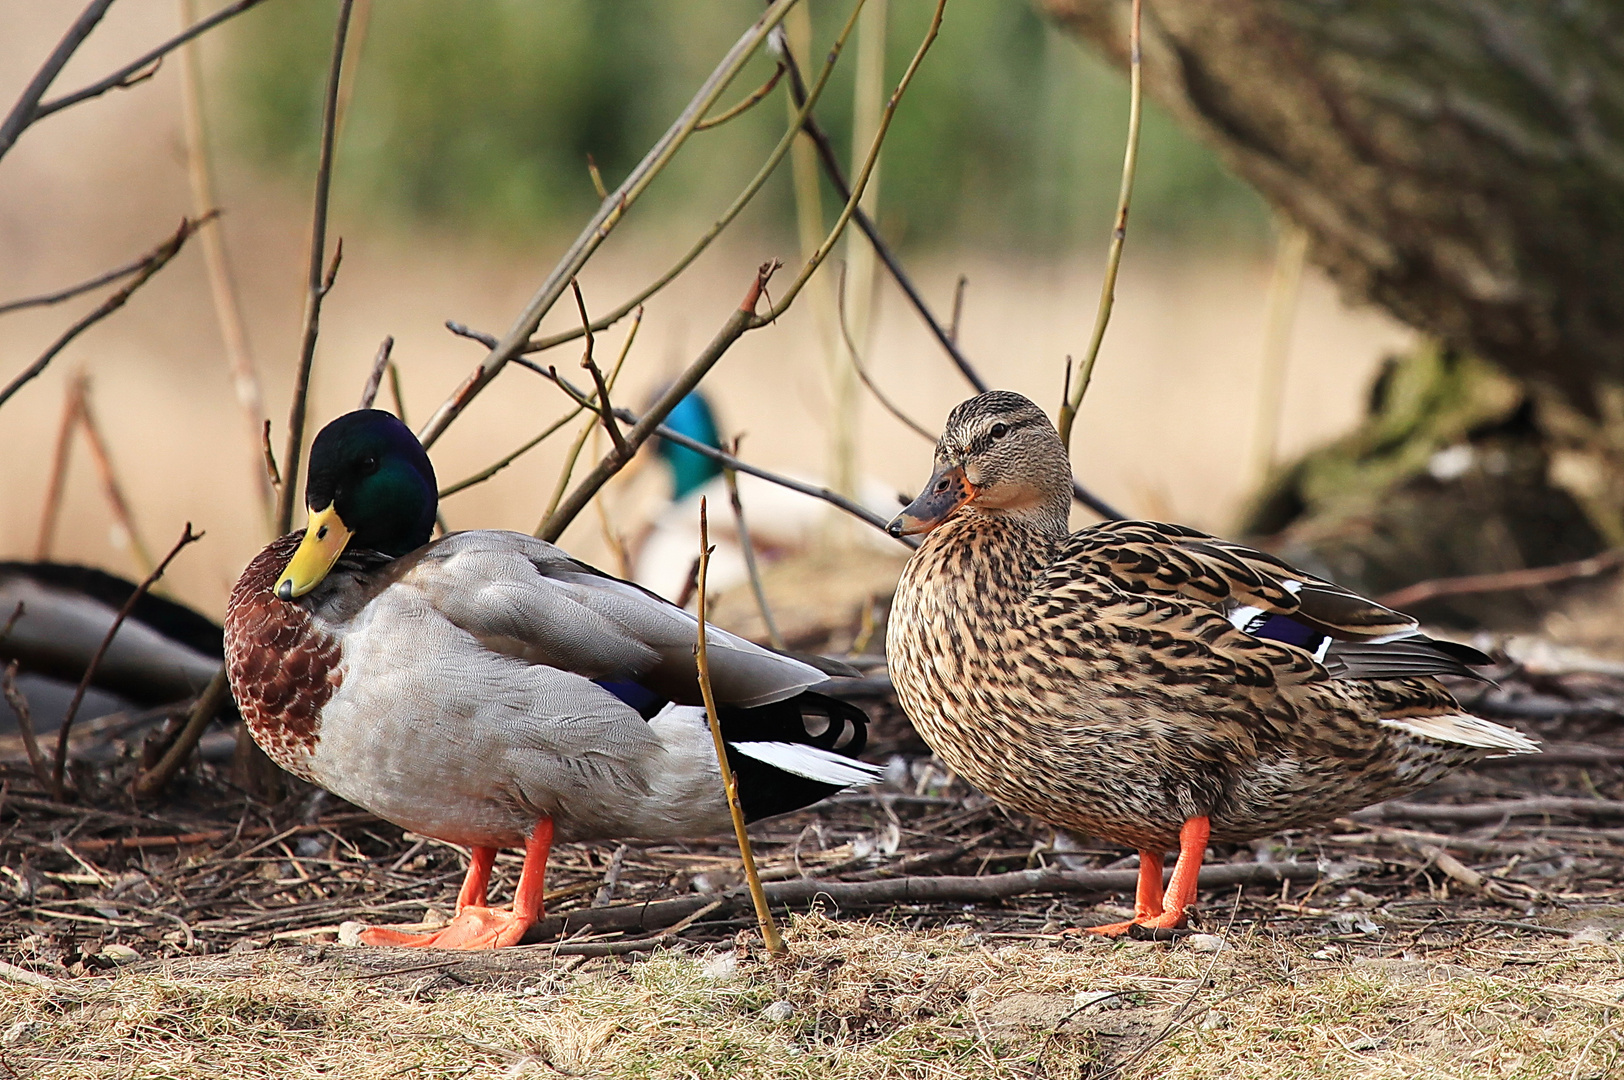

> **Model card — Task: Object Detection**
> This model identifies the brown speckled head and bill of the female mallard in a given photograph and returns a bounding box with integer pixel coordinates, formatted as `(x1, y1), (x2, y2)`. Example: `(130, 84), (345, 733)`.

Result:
(890, 390), (1072, 536)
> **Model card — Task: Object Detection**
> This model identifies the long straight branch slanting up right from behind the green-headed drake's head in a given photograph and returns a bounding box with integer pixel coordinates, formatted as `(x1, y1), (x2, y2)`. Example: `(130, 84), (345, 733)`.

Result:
(417, 0), (796, 448)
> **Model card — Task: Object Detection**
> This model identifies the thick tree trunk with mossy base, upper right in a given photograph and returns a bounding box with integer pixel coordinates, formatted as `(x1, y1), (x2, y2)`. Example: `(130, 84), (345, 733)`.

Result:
(1041, 0), (1624, 620)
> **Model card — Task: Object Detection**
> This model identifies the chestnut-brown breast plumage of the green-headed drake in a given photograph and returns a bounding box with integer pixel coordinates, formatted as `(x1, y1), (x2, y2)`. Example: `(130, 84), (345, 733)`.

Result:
(226, 531), (343, 776)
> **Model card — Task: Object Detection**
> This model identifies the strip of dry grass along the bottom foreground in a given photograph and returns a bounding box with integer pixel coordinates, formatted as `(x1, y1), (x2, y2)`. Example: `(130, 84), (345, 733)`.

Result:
(0, 916), (1624, 1080)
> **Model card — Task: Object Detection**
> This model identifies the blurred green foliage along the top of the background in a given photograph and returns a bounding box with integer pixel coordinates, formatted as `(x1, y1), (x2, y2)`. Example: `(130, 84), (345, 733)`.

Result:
(222, 0), (1267, 252)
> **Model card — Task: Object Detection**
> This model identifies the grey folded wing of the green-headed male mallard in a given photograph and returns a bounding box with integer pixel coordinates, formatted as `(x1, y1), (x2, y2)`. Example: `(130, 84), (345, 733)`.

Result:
(401, 529), (827, 706)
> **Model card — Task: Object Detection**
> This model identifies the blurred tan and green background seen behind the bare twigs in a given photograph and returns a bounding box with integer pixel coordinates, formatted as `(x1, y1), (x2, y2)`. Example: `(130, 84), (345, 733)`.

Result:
(0, 0), (1410, 614)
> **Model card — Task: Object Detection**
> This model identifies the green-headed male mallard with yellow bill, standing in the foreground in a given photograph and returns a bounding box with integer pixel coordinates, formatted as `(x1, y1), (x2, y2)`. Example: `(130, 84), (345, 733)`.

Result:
(226, 409), (877, 948)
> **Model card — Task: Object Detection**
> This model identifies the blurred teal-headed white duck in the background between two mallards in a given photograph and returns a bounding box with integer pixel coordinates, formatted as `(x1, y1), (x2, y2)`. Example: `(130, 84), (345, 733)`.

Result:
(632, 390), (898, 604)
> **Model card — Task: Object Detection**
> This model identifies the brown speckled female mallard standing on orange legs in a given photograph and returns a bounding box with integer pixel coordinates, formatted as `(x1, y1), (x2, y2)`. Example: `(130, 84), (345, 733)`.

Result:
(887, 391), (1538, 934)
